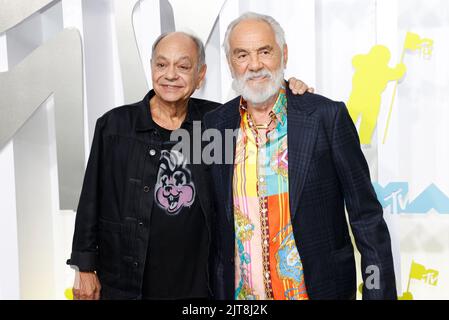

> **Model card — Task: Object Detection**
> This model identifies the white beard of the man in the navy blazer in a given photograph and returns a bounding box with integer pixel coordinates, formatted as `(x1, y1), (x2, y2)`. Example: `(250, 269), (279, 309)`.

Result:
(232, 64), (284, 105)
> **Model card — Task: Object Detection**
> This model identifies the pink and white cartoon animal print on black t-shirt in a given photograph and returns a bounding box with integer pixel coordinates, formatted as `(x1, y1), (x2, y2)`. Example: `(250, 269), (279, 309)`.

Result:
(154, 150), (195, 215)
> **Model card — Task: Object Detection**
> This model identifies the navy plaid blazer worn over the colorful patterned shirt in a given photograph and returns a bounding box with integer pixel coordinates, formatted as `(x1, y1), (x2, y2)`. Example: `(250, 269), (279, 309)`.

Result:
(204, 89), (397, 299)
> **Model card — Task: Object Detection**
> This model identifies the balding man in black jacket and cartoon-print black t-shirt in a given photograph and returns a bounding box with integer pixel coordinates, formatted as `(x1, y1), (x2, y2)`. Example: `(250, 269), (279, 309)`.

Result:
(68, 32), (307, 299)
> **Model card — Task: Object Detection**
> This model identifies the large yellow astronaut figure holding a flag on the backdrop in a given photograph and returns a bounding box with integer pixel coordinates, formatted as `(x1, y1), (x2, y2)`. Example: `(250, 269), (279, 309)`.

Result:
(347, 32), (433, 145)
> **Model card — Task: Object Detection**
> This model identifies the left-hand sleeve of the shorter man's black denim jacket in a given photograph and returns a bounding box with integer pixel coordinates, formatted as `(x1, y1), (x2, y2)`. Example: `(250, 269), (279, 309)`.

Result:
(67, 118), (104, 272)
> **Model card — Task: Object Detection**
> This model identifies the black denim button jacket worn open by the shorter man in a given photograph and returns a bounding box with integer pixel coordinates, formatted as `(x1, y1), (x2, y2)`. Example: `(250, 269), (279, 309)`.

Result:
(67, 91), (219, 299)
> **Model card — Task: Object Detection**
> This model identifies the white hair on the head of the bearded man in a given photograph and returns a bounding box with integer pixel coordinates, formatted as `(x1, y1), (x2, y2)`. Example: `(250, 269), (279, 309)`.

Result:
(223, 12), (285, 58)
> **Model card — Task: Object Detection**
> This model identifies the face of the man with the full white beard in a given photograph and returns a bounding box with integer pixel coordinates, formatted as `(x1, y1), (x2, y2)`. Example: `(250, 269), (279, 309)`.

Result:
(228, 20), (287, 104)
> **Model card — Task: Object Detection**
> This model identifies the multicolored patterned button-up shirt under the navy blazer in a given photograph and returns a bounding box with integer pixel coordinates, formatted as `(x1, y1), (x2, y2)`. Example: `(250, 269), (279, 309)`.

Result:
(233, 89), (308, 300)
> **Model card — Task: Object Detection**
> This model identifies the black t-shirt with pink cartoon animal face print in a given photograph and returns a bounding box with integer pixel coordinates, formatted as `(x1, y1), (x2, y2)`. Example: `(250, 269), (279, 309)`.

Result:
(142, 119), (208, 299)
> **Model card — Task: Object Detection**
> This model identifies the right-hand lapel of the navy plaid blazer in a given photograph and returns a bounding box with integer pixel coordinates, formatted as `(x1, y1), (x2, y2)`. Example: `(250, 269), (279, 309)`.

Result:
(287, 92), (319, 222)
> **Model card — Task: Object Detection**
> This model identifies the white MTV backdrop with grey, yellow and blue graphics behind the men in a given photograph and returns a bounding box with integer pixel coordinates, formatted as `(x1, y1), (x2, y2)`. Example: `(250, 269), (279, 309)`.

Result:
(0, 0), (449, 300)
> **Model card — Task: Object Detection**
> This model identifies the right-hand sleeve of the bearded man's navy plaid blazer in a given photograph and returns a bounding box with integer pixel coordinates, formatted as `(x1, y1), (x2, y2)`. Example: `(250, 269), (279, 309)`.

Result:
(332, 103), (397, 299)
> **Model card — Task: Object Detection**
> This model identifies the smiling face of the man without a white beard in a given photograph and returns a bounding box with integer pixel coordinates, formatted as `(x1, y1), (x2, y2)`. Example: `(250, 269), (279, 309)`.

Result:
(151, 33), (206, 103)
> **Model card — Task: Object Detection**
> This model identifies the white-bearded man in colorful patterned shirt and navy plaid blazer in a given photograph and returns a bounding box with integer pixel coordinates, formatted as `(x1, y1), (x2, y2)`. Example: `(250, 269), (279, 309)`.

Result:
(205, 13), (396, 300)
